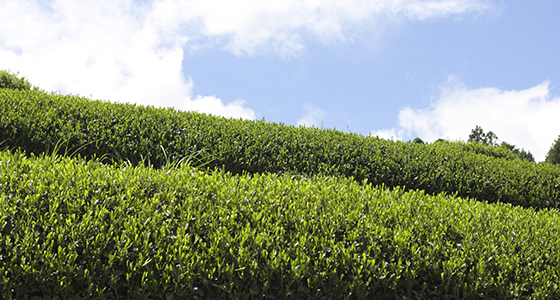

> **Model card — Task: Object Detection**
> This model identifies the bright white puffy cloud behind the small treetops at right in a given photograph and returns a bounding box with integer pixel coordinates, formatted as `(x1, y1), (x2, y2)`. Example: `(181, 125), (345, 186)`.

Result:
(374, 76), (560, 161)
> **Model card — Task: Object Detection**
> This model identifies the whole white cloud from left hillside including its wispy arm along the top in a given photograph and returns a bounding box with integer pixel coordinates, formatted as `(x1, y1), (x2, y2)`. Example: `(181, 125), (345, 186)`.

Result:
(0, 0), (492, 119)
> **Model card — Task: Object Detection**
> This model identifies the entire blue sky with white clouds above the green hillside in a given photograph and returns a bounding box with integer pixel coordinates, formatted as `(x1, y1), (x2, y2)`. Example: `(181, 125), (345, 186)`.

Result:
(0, 0), (560, 161)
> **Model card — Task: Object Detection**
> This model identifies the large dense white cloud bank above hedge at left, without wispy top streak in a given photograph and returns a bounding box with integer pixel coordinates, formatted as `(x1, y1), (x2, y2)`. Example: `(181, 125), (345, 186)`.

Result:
(0, 0), (256, 119)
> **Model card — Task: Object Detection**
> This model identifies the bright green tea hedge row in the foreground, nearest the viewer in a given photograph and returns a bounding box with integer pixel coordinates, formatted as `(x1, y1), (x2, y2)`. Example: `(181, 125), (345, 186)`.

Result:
(0, 151), (560, 300)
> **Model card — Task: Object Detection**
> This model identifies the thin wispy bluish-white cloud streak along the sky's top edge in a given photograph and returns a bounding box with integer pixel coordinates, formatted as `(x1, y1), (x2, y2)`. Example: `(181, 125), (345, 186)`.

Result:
(180, 0), (494, 58)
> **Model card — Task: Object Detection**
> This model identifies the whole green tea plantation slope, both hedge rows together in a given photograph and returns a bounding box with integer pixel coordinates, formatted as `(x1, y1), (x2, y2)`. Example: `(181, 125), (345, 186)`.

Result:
(0, 72), (560, 300)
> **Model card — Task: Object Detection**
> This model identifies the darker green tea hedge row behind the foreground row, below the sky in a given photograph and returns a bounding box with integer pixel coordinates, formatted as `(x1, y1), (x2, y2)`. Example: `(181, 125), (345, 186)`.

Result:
(0, 89), (560, 208)
